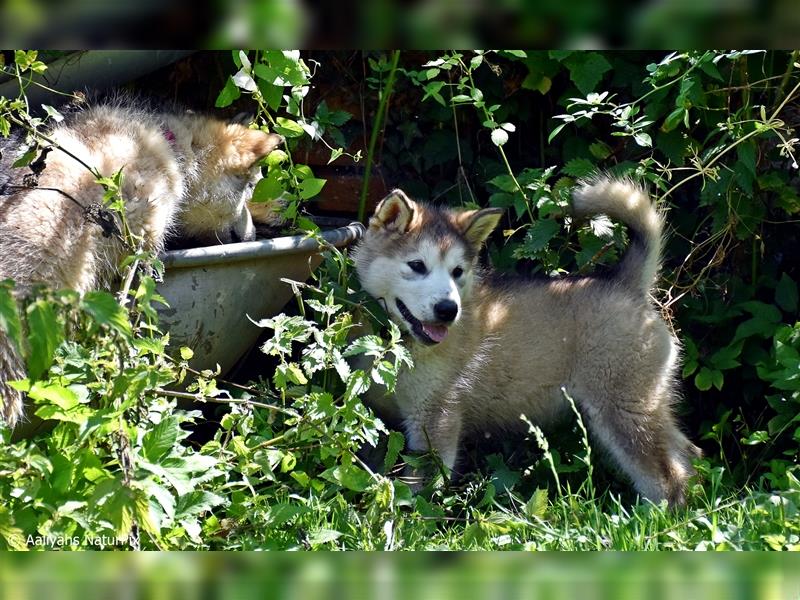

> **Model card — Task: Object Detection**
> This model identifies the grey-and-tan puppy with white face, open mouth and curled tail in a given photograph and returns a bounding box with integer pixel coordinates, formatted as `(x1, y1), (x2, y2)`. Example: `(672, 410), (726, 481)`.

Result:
(355, 178), (699, 505)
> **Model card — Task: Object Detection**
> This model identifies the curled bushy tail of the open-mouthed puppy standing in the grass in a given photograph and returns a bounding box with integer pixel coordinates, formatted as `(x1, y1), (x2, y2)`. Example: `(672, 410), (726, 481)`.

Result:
(573, 176), (664, 295)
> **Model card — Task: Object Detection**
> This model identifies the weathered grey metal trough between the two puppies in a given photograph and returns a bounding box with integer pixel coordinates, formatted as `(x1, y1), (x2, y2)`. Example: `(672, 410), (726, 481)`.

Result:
(158, 223), (364, 376)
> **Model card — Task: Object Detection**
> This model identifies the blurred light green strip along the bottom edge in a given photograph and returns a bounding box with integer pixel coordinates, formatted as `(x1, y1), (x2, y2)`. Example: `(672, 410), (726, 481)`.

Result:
(0, 553), (800, 600)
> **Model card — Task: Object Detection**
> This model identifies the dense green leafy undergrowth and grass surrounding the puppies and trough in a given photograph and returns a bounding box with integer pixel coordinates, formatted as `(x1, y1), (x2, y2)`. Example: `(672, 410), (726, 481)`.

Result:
(0, 51), (800, 549)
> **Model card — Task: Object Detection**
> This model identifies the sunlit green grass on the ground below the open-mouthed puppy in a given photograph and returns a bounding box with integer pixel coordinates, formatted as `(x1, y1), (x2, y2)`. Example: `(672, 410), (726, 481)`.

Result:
(212, 422), (800, 551)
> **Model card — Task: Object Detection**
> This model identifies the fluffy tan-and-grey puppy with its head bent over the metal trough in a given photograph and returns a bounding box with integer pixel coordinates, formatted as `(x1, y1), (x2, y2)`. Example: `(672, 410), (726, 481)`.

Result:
(0, 102), (281, 426)
